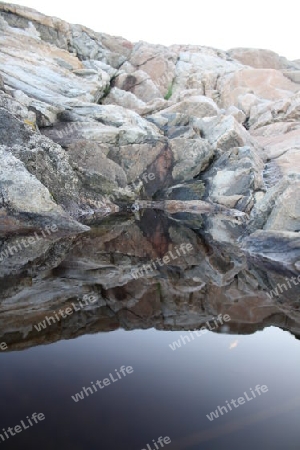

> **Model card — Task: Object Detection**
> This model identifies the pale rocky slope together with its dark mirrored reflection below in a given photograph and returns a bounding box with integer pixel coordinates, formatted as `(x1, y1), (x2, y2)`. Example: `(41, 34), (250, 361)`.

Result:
(0, 3), (300, 349)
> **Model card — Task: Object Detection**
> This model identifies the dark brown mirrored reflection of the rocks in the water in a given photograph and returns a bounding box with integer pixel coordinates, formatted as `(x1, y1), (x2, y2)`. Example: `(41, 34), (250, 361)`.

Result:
(0, 210), (300, 350)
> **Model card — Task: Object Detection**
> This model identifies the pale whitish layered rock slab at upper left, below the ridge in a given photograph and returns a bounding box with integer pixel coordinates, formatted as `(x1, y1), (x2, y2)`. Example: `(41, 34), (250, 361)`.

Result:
(0, 11), (107, 106)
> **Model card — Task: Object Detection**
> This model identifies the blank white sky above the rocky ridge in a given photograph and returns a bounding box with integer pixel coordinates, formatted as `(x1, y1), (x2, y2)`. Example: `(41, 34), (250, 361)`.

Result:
(7, 0), (300, 60)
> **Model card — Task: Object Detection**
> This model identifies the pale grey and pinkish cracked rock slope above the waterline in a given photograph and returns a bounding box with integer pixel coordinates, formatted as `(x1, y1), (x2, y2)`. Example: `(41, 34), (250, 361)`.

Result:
(0, 3), (300, 266)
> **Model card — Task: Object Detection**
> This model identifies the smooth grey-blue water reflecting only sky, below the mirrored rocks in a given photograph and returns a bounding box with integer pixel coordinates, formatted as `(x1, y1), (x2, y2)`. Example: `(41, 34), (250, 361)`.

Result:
(0, 327), (300, 450)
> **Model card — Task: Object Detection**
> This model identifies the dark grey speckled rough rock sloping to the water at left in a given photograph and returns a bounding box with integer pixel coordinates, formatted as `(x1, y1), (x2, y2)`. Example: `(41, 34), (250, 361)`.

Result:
(0, 108), (124, 223)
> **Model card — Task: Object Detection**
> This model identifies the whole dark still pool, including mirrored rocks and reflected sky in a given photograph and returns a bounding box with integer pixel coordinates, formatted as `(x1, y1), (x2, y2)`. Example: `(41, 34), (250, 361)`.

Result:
(0, 216), (300, 450)
